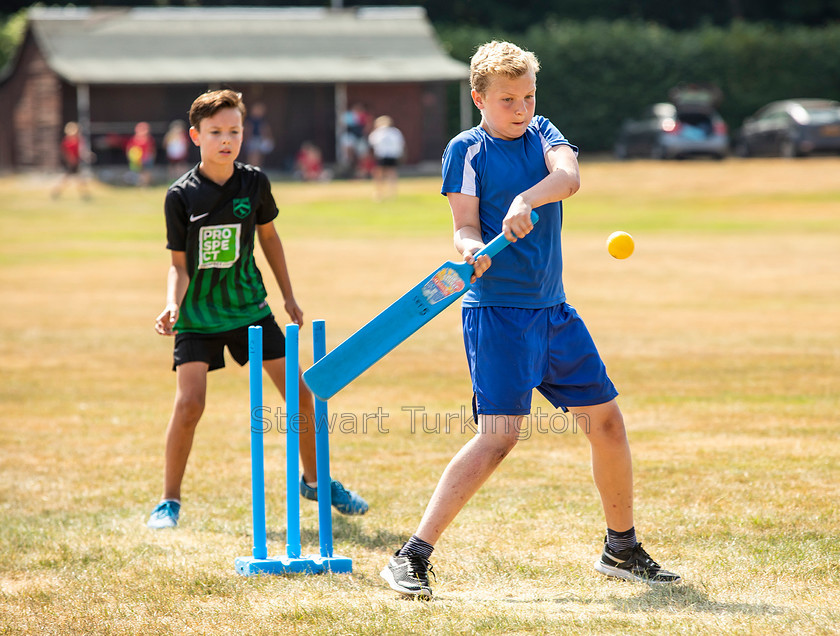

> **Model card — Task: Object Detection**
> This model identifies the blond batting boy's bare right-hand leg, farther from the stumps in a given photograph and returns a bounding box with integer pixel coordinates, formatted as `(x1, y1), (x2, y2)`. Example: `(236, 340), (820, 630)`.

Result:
(569, 400), (633, 532)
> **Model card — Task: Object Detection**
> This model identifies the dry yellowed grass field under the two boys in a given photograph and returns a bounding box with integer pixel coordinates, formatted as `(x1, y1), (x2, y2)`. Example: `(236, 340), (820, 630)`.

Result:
(0, 159), (840, 635)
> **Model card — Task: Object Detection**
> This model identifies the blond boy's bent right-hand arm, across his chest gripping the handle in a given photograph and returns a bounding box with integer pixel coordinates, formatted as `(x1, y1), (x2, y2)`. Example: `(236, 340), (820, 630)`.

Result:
(502, 145), (580, 241)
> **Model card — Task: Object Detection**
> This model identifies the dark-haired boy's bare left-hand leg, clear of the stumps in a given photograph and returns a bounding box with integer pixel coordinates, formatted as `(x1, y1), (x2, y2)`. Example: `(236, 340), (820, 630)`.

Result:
(163, 362), (209, 500)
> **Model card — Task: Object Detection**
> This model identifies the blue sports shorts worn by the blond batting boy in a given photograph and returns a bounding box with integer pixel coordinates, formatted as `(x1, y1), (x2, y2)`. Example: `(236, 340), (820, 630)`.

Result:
(462, 303), (618, 415)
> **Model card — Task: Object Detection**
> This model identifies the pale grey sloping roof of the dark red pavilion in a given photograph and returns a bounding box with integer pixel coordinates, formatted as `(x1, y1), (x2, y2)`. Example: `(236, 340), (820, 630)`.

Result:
(28, 7), (469, 84)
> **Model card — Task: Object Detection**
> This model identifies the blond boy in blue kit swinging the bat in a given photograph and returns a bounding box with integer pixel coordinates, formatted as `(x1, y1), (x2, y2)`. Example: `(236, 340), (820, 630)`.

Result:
(382, 41), (680, 598)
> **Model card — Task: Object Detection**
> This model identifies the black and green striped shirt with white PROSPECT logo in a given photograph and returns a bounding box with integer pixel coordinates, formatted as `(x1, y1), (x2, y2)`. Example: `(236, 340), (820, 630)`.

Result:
(165, 162), (277, 333)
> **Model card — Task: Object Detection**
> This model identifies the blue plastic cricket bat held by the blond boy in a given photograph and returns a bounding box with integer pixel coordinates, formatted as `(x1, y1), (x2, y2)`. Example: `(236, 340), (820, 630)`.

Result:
(303, 211), (539, 400)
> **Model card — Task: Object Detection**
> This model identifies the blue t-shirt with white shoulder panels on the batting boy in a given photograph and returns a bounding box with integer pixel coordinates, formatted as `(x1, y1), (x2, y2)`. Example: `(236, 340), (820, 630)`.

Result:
(441, 115), (577, 309)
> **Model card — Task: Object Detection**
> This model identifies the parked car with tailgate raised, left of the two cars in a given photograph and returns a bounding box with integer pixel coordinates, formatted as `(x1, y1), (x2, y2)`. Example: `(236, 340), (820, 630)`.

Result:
(615, 102), (729, 159)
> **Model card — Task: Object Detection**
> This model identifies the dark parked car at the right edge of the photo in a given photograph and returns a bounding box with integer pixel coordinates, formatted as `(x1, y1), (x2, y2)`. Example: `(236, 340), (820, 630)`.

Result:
(735, 99), (840, 157)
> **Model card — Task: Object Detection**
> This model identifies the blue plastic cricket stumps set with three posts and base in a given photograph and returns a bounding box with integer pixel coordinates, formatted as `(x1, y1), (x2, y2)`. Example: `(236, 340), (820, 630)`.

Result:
(234, 320), (353, 576)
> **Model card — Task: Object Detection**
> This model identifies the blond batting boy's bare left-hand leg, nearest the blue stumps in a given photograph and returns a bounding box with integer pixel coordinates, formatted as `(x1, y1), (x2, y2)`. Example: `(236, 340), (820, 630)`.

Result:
(414, 415), (522, 545)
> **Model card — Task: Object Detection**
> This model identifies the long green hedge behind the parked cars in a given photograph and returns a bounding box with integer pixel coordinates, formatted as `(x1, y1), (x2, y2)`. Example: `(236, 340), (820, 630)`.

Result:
(439, 21), (840, 152)
